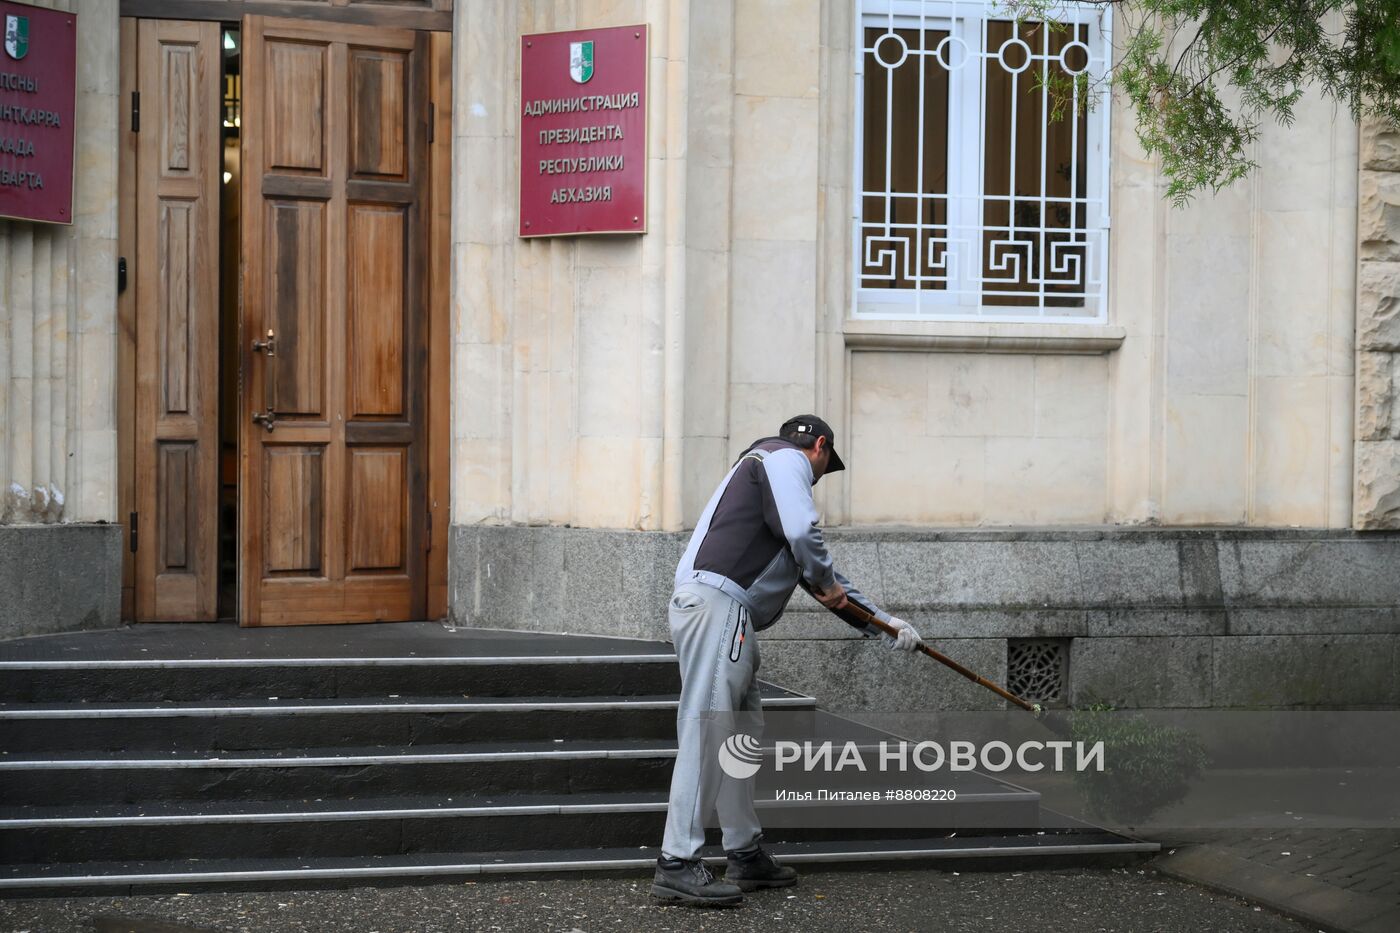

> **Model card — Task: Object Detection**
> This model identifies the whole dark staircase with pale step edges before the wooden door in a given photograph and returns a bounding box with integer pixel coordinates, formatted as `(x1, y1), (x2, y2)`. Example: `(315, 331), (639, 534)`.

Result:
(0, 623), (1156, 897)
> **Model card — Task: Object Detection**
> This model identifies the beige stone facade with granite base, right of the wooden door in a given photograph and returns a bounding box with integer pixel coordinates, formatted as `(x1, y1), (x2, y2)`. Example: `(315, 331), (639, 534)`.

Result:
(449, 0), (1400, 710)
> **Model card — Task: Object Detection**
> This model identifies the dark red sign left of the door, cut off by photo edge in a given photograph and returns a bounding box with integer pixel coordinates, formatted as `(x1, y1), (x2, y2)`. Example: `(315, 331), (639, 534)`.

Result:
(0, 0), (78, 224)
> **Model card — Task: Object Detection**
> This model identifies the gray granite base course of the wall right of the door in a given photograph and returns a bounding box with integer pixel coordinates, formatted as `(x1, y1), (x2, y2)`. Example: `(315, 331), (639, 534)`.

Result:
(451, 525), (1400, 710)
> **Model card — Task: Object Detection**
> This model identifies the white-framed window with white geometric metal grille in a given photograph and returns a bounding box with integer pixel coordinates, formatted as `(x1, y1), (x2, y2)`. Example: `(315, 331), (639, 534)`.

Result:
(853, 0), (1112, 324)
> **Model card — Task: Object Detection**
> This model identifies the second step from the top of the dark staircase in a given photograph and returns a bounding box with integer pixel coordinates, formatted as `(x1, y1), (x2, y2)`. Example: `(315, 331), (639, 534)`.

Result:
(0, 686), (816, 755)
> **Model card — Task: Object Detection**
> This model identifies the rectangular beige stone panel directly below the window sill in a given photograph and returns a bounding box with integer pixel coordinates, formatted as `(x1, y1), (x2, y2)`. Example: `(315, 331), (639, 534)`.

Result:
(850, 352), (1109, 525)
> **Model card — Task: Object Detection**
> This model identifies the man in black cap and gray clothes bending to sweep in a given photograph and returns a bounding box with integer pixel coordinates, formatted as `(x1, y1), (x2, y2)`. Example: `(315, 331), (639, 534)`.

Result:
(651, 415), (920, 906)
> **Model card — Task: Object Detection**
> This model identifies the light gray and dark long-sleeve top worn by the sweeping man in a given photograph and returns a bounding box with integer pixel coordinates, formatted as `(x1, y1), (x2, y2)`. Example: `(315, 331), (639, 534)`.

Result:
(676, 437), (890, 635)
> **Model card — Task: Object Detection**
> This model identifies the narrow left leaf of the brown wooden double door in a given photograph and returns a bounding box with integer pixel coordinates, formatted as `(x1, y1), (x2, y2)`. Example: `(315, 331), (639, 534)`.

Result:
(134, 21), (221, 622)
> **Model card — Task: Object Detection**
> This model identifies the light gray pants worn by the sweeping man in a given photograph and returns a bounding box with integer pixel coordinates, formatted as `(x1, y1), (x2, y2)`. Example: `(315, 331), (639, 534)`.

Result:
(661, 583), (763, 859)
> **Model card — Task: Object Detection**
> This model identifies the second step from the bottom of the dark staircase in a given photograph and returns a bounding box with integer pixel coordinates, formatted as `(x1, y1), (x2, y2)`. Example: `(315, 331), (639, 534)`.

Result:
(0, 787), (1039, 864)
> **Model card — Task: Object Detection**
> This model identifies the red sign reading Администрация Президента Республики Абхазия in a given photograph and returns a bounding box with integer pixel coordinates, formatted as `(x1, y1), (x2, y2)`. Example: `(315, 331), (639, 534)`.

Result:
(519, 25), (648, 237)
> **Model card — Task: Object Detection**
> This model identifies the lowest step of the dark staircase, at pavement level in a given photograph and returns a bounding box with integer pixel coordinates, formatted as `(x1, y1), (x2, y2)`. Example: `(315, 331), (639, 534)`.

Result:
(0, 831), (1158, 897)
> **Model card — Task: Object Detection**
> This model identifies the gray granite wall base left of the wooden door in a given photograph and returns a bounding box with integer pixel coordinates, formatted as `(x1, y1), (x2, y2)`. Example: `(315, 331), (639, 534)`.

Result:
(0, 524), (122, 639)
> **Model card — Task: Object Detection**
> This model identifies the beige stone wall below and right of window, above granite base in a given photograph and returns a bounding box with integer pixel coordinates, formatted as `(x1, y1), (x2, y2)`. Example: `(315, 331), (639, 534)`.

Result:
(826, 10), (1357, 527)
